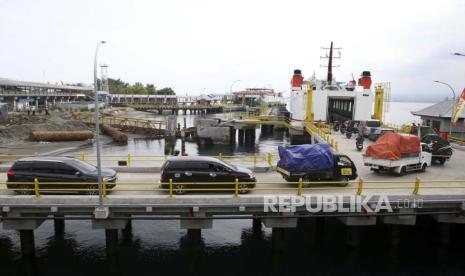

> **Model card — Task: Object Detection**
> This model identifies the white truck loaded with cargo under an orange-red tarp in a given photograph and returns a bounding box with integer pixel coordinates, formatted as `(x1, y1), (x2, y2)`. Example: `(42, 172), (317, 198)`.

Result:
(363, 133), (431, 175)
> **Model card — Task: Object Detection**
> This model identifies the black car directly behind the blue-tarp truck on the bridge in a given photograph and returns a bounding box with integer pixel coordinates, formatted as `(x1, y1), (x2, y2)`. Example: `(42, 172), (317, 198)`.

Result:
(160, 156), (256, 194)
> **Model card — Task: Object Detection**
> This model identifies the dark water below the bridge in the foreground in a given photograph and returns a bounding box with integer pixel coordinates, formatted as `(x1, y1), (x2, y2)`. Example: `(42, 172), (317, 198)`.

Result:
(0, 219), (465, 276)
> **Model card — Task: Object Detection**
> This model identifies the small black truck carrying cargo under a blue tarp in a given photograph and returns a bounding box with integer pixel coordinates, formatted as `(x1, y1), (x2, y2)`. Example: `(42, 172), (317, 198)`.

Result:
(277, 144), (357, 185)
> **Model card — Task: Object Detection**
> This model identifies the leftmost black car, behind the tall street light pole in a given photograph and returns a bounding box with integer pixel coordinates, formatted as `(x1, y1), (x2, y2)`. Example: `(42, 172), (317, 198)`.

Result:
(7, 156), (117, 194)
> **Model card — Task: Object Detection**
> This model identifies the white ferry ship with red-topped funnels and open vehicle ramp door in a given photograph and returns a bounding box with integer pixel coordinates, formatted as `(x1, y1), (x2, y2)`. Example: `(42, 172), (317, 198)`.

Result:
(289, 42), (383, 127)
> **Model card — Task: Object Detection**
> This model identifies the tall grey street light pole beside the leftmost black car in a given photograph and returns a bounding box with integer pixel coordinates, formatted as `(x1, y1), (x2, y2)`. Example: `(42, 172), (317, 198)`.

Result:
(94, 41), (106, 207)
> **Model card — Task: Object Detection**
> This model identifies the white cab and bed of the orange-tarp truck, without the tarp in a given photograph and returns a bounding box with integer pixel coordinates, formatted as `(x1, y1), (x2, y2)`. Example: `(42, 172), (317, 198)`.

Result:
(363, 143), (432, 175)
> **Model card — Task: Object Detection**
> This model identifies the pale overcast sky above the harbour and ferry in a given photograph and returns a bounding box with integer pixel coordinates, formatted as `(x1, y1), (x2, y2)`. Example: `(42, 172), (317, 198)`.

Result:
(0, 0), (465, 100)
